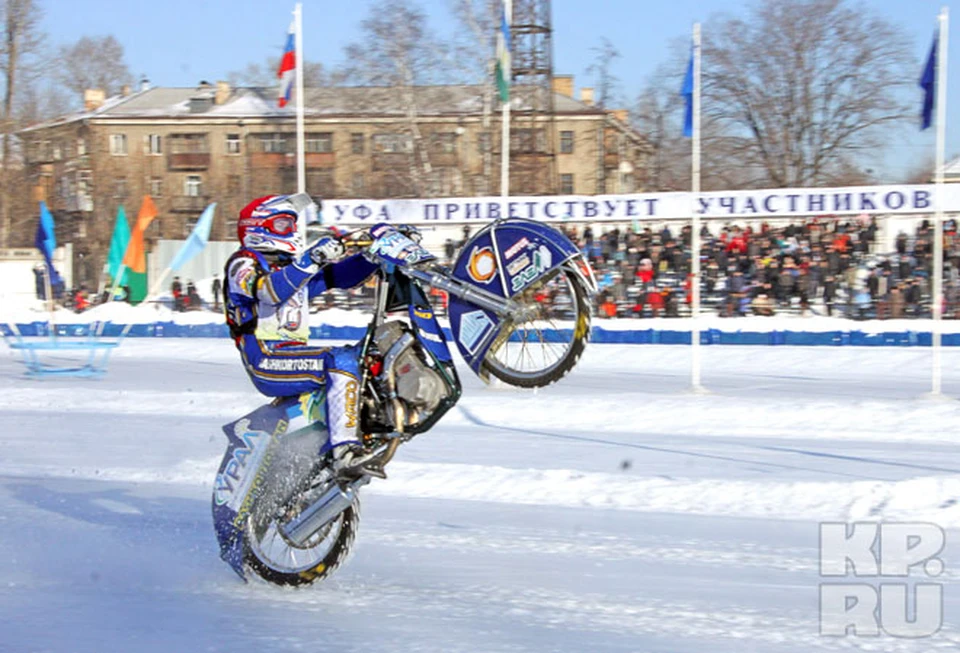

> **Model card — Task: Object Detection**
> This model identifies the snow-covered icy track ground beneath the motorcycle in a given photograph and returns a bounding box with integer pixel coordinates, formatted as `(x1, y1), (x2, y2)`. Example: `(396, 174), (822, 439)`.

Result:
(0, 339), (960, 653)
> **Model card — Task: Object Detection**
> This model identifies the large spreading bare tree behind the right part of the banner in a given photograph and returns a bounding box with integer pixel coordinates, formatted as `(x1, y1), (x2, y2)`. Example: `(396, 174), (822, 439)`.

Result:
(703, 0), (914, 187)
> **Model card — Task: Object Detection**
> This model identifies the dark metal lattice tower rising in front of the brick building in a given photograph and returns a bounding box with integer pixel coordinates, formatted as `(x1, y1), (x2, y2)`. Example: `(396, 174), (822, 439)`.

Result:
(510, 0), (557, 195)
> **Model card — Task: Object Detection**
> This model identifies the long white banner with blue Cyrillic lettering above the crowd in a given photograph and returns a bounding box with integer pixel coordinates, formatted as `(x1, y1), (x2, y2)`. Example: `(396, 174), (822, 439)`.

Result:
(323, 184), (960, 226)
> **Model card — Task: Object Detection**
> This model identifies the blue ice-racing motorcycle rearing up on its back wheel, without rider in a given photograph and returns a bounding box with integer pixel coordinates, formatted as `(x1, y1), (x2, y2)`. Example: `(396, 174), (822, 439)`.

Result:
(213, 218), (597, 586)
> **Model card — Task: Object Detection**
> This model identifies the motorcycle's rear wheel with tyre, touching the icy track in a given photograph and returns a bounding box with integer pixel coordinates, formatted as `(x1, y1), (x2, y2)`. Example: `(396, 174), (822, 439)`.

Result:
(244, 484), (360, 586)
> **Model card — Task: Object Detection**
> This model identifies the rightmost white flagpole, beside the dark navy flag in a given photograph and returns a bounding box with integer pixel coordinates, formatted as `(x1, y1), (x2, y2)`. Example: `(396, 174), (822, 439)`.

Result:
(931, 7), (949, 396)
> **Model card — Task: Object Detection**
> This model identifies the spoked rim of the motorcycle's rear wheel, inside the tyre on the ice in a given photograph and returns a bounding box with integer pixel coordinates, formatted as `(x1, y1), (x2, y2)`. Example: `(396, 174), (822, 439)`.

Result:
(247, 496), (350, 573)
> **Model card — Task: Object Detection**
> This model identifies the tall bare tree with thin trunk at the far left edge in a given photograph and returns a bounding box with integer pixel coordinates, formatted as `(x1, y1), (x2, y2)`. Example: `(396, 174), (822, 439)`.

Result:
(0, 0), (43, 247)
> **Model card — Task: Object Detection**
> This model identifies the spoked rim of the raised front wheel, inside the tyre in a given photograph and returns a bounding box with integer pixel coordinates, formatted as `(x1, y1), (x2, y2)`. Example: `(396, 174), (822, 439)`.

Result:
(485, 270), (581, 380)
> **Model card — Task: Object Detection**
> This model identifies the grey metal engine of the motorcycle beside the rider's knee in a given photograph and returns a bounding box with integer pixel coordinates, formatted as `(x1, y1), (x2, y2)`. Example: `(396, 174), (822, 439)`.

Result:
(373, 320), (450, 426)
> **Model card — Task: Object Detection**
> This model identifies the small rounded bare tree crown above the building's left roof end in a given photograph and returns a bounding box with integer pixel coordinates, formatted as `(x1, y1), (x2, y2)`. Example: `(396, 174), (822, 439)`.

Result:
(55, 35), (133, 102)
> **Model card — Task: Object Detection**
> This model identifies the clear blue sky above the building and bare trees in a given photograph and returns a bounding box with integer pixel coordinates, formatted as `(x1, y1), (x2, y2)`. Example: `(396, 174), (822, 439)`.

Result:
(40, 0), (960, 182)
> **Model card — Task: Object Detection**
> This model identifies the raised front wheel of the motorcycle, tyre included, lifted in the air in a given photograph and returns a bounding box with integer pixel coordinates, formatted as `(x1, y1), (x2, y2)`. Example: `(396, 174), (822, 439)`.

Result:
(481, 268), (590, 388)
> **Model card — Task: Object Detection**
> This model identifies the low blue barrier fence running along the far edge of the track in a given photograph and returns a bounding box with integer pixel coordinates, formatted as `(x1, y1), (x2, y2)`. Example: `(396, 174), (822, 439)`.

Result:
(0, 322), (960, 347)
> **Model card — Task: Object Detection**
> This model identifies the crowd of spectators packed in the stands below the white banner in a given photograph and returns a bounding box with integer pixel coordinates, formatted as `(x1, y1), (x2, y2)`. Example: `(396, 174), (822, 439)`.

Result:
(565, 218), (960, 319)
